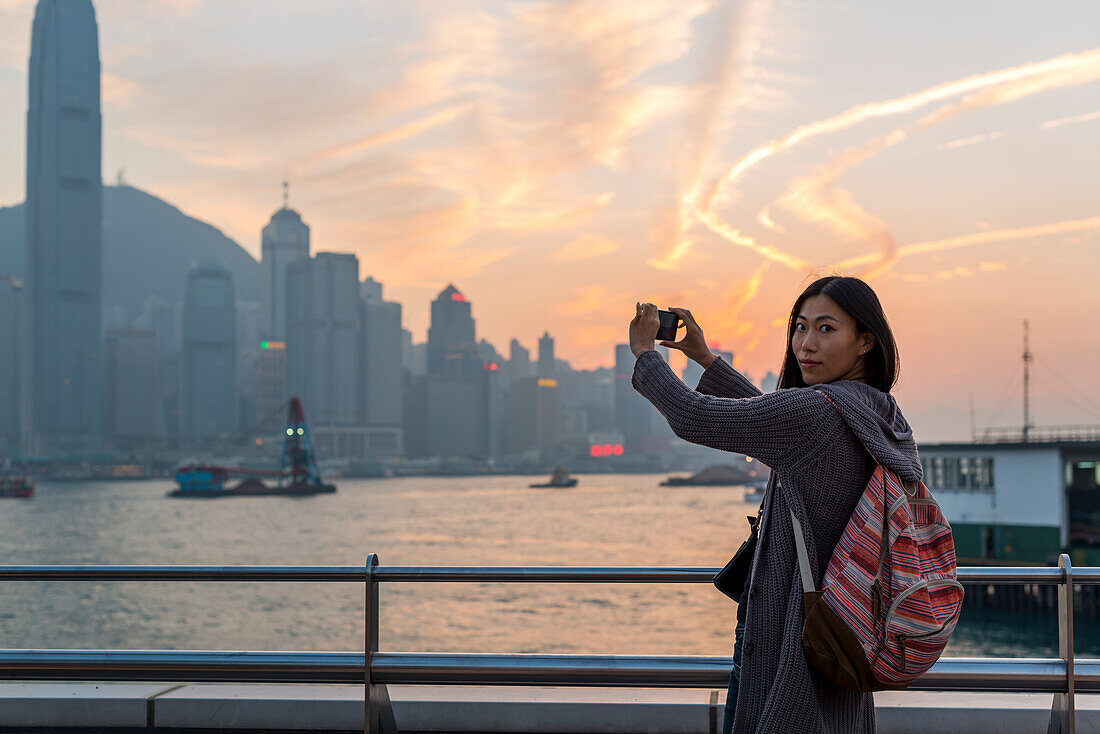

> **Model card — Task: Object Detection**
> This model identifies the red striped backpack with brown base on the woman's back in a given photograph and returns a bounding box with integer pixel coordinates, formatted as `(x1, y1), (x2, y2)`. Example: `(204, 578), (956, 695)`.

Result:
(791, 401), (963, 692)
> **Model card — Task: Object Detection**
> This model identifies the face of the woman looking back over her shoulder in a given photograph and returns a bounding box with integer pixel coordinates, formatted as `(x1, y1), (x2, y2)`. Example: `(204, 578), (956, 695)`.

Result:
(791, 294), (875, 385)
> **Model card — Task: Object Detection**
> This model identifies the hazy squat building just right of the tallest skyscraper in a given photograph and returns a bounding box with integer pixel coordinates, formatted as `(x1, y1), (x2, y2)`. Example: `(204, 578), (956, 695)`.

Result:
(103, 329), (161, 449)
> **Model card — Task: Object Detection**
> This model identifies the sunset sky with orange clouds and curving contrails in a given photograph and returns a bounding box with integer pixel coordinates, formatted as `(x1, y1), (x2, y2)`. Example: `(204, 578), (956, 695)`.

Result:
(0, 0), (1100, 440)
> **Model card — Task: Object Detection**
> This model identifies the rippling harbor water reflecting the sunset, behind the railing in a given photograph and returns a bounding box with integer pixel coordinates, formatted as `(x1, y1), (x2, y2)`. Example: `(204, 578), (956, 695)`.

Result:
(0, 474), (1073, 656)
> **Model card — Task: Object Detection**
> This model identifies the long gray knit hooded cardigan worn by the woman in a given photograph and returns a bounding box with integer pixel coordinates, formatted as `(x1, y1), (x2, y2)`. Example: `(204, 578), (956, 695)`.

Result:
(633, 351), (921, 734)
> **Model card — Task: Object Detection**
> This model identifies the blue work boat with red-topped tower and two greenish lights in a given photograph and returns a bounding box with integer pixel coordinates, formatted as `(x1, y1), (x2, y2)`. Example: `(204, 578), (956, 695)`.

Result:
(168, 397), (337, 499)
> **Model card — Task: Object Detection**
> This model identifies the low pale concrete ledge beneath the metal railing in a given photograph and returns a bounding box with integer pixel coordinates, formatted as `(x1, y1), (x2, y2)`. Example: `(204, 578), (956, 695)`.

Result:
(0, 682), (1086, 734)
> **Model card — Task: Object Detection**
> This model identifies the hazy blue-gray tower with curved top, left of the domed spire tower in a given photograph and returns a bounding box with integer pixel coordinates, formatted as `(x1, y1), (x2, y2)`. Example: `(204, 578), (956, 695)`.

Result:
(179, 263), (238, 442)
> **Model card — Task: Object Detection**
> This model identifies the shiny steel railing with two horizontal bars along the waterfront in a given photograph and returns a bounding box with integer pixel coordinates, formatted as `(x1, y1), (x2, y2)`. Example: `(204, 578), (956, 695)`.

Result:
(0, 554), (1086, 734)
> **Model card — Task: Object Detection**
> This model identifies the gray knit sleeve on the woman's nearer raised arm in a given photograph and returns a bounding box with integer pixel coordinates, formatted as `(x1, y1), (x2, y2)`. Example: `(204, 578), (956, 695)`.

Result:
(631, 351), (831, 468)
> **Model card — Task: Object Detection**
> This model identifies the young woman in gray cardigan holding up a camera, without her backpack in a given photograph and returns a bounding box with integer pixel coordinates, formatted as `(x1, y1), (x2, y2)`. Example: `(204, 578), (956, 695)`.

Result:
(630, 276), (921, 734)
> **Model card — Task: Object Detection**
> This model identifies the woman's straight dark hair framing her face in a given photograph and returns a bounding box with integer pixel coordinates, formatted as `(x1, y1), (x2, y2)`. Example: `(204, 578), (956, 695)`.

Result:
(779, 275), (899, 393)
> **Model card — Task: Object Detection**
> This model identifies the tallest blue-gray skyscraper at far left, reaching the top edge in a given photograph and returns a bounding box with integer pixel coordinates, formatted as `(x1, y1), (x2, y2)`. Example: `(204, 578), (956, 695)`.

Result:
(24, 0), (102, 452)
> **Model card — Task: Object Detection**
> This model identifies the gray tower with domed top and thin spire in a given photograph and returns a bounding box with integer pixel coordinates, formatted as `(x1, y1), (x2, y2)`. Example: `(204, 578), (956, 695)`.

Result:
(260, 177), (309, 341)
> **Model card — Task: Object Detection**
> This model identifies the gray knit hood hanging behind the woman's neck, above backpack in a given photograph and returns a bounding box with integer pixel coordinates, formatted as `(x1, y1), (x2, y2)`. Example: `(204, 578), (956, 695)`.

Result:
(813, 380), (923, 482)
